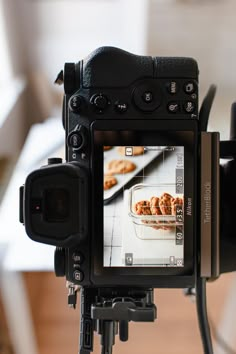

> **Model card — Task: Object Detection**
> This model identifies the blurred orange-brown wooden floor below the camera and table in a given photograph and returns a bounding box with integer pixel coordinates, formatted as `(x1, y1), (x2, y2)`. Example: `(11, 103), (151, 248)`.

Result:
(20, 273), (236, 354)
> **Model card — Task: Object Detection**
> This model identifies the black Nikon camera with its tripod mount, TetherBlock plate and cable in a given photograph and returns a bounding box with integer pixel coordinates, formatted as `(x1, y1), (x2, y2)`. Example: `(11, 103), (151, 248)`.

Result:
(20, 47), (236, 354)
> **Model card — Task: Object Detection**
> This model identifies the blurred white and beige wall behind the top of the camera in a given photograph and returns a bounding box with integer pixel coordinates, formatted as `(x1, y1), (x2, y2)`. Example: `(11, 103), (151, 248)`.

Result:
(0, 0), (236, 148)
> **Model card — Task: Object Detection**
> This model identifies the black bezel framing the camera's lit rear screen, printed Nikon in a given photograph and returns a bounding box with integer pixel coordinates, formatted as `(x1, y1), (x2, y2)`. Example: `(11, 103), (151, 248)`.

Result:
(90, 119), (197, 285)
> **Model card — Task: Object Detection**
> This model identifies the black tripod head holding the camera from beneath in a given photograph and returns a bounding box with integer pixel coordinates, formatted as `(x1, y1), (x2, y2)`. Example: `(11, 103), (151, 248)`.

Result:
(80, 288), (156, 354)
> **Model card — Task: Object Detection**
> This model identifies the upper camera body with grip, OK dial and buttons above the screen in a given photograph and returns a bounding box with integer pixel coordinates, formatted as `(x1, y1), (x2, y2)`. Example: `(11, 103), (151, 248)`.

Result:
(64, 47), (198, 125)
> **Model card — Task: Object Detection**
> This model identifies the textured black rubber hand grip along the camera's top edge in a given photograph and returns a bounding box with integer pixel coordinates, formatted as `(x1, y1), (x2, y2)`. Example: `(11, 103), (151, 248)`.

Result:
(76, 47), (198, 88)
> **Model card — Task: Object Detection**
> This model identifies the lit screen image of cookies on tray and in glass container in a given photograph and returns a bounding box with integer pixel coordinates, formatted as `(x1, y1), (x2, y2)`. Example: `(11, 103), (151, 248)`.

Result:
(103, 146), (184, 267)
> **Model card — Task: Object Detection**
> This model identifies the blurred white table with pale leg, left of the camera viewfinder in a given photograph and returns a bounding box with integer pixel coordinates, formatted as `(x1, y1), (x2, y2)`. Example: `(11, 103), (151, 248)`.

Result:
(0, 118), (64, 354)
